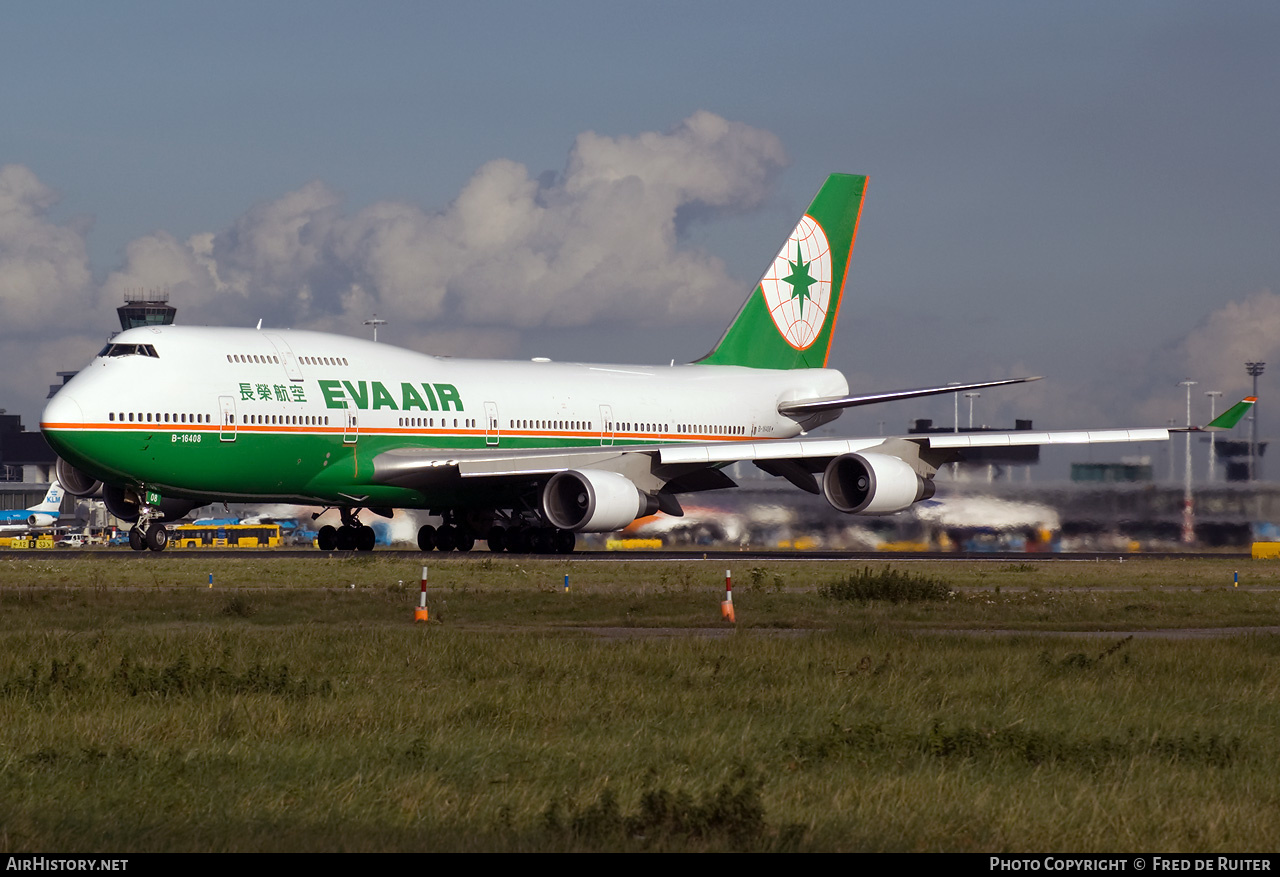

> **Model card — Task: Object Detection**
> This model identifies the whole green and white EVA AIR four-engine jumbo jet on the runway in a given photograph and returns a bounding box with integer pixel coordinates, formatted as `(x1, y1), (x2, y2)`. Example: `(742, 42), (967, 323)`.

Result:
(32, 174), (1208, 552)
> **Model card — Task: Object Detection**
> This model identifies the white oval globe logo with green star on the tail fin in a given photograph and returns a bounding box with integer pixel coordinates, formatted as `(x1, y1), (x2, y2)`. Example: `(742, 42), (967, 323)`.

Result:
(760, 215), (831, 351)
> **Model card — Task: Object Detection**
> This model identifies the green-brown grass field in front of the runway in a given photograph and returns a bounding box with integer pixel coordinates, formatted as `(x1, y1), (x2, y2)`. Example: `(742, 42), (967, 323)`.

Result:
(0, 554), (1280, 853)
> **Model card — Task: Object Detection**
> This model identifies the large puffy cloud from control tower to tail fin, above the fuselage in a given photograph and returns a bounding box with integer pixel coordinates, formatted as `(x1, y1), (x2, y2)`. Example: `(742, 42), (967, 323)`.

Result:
(106, 113), (786, 330)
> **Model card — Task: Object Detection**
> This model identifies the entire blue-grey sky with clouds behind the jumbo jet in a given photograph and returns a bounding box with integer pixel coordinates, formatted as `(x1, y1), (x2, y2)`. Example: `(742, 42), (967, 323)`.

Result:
(0, 0), (1280, 475)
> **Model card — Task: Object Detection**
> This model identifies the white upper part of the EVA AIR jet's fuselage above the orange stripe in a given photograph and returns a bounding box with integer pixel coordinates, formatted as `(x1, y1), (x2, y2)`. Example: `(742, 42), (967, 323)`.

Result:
(44, 326), (847, 440)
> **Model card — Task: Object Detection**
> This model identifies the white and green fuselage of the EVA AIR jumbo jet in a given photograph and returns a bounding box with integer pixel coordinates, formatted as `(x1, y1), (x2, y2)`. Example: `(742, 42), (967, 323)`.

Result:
(41, 326), (847, 508)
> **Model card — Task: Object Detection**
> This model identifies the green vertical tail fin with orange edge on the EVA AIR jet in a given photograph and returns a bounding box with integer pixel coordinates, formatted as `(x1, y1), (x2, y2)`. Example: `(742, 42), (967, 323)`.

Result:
(698, 174), (867, 369)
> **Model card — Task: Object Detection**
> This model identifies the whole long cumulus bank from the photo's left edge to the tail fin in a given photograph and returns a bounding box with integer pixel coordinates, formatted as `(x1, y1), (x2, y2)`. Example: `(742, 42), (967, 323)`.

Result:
(0, 111), (786, 422)
